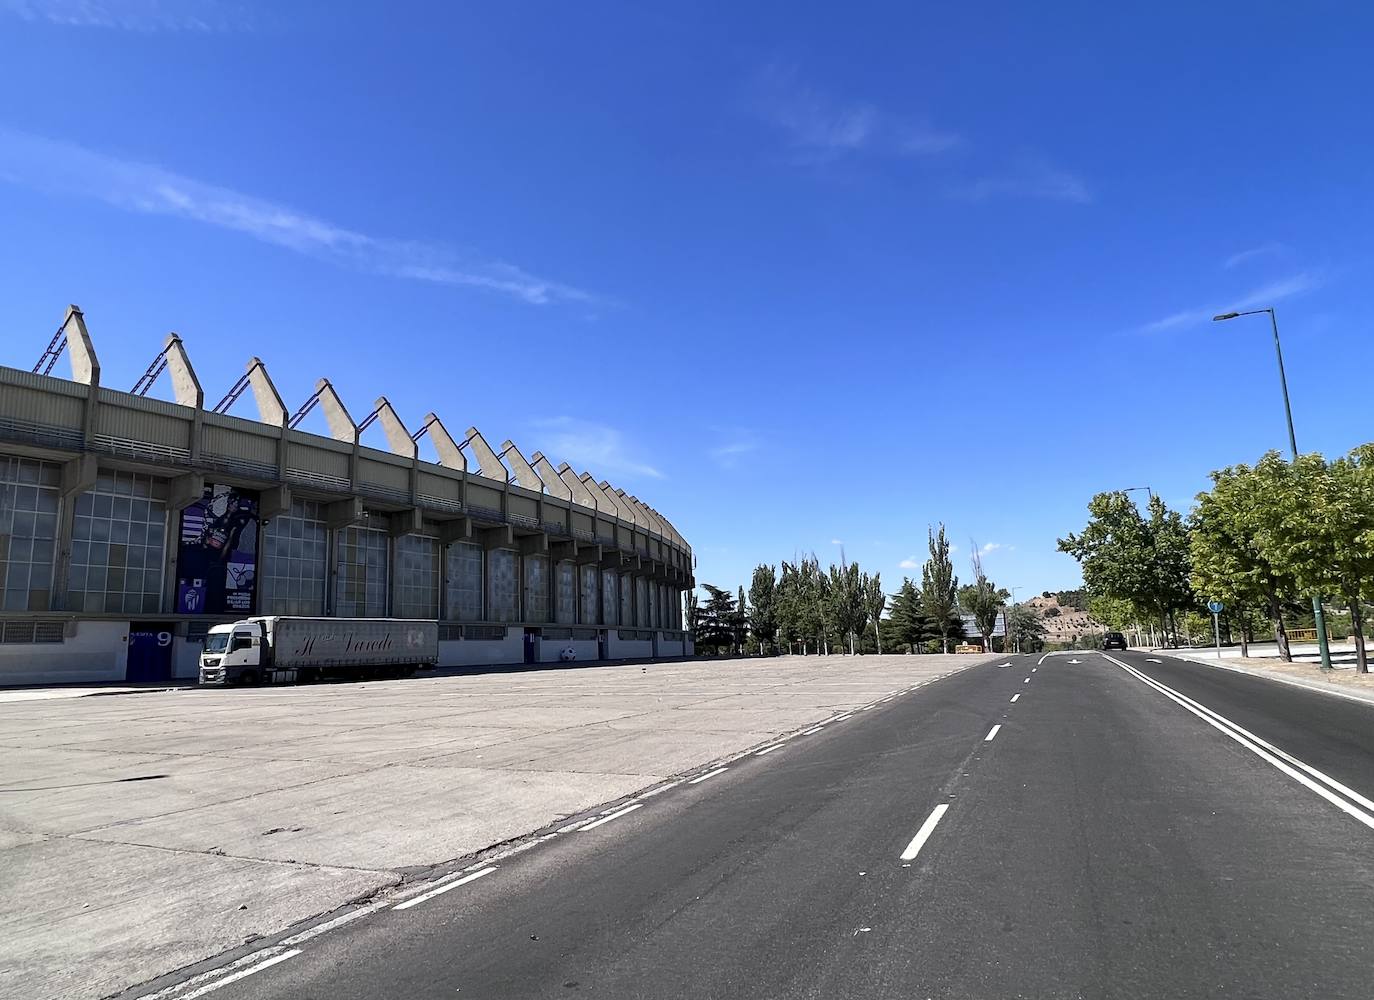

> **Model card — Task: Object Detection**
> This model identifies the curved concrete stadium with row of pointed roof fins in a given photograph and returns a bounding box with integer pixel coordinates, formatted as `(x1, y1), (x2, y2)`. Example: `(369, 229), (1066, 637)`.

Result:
(0, 306), (695, 684)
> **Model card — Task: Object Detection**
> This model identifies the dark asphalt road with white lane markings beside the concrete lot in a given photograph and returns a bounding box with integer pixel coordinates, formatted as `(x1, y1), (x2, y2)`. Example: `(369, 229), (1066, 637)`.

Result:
(165, 652), (1374, 1000)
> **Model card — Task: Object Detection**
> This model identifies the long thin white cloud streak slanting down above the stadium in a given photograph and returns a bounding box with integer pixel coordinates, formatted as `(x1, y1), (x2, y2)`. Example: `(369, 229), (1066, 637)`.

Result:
(0, 128), (600, 305)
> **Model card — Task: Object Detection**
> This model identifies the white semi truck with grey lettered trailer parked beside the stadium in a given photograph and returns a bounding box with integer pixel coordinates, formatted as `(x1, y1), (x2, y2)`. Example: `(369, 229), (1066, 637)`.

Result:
(201, 615), (438, 684)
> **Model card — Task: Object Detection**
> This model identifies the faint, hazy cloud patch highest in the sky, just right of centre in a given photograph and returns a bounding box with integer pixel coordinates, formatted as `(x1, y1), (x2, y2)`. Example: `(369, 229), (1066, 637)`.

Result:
(750, 66), (963, 162)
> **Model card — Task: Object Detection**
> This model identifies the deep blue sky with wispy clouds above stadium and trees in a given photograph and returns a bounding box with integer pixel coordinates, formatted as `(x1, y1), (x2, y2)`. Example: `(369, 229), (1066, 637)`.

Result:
(0, 0), (1374, 593)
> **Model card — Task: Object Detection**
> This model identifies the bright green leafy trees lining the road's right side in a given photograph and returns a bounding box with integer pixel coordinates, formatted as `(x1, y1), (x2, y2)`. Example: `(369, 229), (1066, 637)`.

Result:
(1059, 444), (1374, 673)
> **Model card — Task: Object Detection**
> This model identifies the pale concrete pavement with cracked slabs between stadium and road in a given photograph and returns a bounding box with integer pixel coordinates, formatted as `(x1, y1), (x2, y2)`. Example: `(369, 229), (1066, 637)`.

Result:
(0, 657), (988, 1000)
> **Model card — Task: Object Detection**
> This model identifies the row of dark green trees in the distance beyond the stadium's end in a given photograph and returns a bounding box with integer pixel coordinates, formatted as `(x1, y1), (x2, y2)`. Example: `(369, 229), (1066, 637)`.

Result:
(688, 525), (1044, 654)
